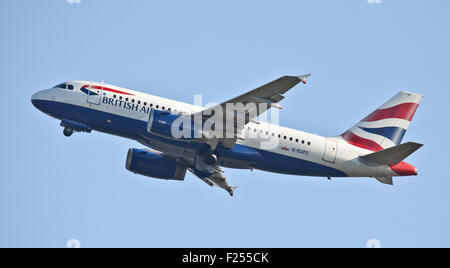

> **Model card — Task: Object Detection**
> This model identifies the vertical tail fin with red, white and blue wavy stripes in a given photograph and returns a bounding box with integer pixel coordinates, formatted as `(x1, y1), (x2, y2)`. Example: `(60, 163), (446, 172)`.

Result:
(341, 91), (422, 151)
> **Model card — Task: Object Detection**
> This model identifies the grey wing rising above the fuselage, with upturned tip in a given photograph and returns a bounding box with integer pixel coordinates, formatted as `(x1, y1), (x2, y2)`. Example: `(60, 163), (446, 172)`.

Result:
(193, 74), (310, 148)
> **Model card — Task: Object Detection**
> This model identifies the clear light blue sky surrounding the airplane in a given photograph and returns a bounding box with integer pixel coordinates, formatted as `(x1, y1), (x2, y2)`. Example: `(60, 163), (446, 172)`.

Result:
(0, 0), (450, 247)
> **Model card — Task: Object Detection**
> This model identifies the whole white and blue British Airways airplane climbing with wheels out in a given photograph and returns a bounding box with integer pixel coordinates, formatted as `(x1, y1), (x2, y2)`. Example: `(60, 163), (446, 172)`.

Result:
(31, 74), (422, 196)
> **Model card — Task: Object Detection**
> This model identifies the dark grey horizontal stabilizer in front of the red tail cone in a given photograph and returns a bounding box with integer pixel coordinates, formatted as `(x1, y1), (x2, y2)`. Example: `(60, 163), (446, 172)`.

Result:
(360, 142), (423, 166)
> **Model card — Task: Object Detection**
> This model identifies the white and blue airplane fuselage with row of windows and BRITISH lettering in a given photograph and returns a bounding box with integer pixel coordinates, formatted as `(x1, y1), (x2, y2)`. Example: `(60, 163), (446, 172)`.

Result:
(32, 81), (404, 177)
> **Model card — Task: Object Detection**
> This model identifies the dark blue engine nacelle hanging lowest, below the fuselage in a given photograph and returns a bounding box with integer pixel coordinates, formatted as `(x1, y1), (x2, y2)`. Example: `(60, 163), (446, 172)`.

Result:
(126, 149), (186, 181)
